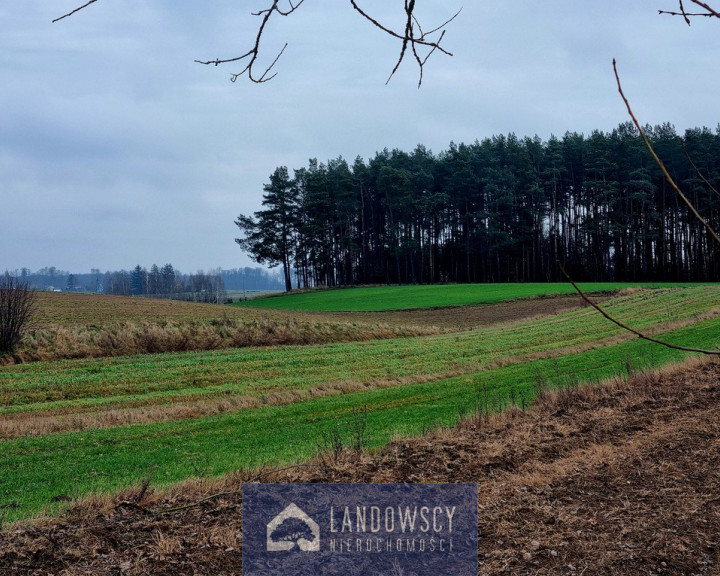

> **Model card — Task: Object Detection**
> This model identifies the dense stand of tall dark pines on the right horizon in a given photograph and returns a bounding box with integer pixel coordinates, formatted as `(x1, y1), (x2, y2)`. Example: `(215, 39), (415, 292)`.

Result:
(235, 122), (720, 290)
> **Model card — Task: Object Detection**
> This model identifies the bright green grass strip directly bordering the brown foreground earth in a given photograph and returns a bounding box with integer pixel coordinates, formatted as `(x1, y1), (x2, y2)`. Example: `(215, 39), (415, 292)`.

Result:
(0, 318), (720, 520)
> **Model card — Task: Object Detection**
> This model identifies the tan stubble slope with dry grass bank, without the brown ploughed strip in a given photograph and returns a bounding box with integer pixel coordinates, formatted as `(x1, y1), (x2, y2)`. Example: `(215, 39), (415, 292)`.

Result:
(12, 293), (444, 362)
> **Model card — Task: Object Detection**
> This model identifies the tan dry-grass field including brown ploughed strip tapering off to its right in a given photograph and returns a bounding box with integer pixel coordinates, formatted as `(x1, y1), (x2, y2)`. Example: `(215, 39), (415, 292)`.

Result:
(7, 292), (583, 362)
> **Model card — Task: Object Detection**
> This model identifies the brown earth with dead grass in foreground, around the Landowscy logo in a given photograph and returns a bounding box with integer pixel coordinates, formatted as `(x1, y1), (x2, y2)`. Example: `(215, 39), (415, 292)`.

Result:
(0, 362), (720, 576)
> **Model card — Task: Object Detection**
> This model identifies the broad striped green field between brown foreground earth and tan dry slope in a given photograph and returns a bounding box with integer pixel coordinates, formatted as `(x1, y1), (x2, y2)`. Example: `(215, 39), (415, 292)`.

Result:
(0, 285), (720, 520)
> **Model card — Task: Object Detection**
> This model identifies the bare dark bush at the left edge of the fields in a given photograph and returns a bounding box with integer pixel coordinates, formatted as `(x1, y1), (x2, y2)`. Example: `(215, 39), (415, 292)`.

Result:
(0, 272), (35, 354)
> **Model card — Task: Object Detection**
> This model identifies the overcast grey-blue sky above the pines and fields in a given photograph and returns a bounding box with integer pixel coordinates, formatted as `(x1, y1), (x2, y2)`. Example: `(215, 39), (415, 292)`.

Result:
(0, 0), (720, 273)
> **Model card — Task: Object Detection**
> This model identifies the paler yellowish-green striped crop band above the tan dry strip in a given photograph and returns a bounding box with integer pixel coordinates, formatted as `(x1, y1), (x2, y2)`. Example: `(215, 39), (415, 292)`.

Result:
(0, 287), (717, 413)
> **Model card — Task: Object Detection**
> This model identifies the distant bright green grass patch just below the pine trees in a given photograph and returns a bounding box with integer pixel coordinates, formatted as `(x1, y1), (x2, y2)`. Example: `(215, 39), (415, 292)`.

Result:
(236, 282), (688, 312)
